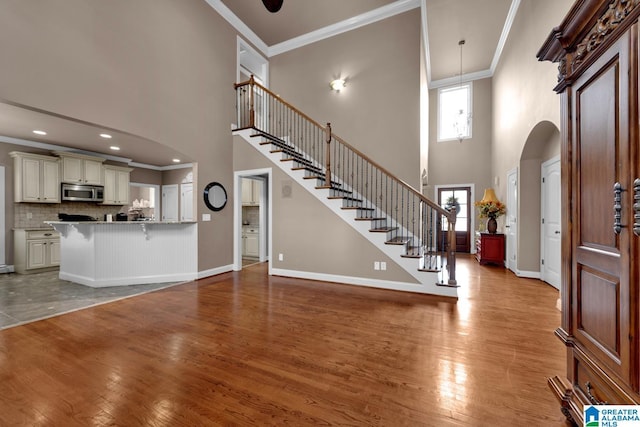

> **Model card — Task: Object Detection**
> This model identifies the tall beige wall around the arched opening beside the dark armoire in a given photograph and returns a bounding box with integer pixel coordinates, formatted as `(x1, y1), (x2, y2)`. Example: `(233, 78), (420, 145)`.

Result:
(491, 0), (573, 271)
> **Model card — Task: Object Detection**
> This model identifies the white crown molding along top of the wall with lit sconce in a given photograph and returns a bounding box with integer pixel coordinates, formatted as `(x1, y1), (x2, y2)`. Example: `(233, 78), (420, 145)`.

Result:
(268, 0), (421, 57)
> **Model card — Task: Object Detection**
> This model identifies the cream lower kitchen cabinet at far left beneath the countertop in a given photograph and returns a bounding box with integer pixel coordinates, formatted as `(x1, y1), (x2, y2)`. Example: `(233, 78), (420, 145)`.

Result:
(14, 229), (60, 274)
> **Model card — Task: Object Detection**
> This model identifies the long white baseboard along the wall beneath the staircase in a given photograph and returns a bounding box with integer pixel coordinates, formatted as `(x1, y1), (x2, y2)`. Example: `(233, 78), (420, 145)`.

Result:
(271, 268), (458, 298)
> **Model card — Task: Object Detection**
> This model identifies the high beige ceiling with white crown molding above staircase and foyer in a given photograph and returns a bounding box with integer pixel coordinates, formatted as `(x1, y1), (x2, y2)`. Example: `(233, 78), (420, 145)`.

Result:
(218, 0), (520, 87)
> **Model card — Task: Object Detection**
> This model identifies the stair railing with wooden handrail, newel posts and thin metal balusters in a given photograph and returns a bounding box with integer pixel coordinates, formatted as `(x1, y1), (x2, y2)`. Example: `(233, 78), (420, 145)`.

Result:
(234, 76), (457, 286)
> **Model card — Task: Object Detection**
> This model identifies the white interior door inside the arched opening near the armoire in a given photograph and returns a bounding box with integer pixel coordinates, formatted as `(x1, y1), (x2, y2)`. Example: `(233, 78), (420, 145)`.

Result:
(540, 157), (562, 289)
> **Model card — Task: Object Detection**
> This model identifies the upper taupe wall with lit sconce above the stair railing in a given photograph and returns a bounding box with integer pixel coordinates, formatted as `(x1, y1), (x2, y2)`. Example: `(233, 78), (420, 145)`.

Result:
(270, 9), (420, 190)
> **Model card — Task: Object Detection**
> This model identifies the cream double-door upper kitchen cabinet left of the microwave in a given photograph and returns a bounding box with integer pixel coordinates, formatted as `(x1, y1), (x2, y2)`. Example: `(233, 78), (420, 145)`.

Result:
(9, 151), (60, 203)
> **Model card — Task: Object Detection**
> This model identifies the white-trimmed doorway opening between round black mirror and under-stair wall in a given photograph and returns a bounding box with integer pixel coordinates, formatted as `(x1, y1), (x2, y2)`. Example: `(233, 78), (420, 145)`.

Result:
(233, 169), (272, 272)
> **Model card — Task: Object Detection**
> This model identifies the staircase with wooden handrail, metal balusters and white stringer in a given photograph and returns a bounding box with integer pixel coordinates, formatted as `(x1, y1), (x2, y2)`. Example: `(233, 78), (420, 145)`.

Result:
(234, 77), (457, 296)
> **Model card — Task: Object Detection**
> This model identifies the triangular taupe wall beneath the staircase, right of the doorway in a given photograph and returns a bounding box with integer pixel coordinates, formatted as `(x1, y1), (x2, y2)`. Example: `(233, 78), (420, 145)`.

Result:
(233, 137), (417, 283)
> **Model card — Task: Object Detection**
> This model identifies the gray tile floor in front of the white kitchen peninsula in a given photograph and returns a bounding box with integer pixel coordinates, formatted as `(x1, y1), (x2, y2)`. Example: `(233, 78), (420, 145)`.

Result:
(0, 271), (176, 330)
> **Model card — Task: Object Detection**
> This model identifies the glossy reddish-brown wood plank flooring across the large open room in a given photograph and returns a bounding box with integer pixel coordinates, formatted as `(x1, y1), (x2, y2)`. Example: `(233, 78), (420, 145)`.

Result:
(0, 256), (567, 426)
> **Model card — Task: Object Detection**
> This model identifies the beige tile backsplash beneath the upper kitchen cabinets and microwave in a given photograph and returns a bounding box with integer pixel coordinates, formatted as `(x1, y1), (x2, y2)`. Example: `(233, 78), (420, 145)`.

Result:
(13, 202), (127, 228)
